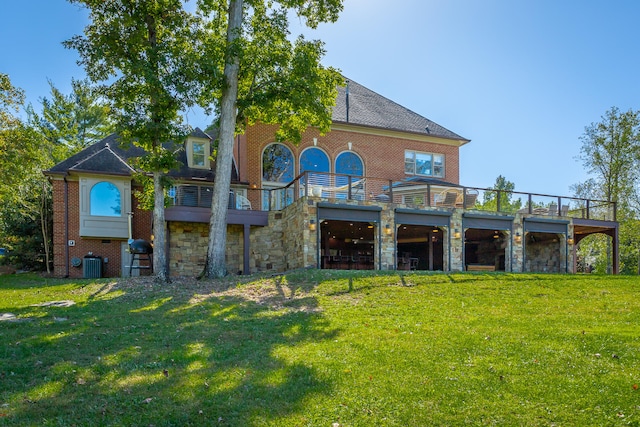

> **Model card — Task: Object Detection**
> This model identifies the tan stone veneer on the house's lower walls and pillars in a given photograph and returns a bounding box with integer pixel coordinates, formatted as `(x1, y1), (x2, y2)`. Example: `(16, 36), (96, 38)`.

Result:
(169, 197), (574, 276)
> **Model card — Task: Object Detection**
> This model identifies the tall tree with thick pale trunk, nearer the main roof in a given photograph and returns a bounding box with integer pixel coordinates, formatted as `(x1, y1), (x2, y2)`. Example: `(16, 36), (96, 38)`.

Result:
(200, 0), (342, 277)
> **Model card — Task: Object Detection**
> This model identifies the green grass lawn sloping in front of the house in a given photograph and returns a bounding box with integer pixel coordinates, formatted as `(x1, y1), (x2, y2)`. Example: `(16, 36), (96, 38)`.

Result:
(0, 270), (640, 426)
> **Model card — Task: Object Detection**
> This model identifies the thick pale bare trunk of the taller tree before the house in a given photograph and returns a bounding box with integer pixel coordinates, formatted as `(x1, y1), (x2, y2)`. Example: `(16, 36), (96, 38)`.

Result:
(204, 0), (243, 278)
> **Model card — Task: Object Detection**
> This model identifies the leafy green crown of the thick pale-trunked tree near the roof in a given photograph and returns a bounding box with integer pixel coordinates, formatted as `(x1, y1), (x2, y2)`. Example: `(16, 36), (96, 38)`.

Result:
(200, 0), (344, 142)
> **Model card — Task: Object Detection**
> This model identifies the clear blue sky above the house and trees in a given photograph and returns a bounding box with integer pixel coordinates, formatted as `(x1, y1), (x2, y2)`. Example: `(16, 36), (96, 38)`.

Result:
(0, 0), (640, 195)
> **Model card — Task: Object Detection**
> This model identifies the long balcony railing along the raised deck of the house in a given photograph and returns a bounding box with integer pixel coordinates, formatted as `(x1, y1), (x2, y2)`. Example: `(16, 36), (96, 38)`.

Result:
(169, 172), (616, 221)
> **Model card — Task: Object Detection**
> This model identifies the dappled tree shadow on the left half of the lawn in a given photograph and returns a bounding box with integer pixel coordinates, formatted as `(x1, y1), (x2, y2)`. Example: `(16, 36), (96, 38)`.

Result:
(0, 284), (337, 426)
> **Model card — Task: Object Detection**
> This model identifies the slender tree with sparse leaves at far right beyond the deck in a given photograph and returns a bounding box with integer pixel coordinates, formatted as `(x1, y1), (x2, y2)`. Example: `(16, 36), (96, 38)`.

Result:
(573, 107), (640, 273)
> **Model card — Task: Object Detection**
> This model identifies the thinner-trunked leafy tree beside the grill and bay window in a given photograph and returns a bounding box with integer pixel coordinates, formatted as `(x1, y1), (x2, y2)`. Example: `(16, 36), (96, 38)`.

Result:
(65, 0), (197, 281)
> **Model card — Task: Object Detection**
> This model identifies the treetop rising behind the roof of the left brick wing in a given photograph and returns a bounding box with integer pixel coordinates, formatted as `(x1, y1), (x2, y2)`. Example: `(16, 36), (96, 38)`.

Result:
(27, 79), (113, 154)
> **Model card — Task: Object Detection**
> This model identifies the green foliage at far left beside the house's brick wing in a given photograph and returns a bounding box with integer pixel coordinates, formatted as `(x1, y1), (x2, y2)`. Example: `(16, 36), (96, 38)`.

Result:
(0, 74), (110, 270)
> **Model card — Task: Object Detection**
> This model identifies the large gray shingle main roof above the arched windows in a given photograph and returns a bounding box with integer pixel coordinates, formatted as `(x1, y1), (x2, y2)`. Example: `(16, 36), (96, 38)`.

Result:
(332, 79), (469, 142)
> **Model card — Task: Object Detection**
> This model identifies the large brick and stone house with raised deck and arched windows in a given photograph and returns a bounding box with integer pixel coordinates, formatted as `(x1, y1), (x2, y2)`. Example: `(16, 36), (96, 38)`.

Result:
(45, 77), (618, 277)
